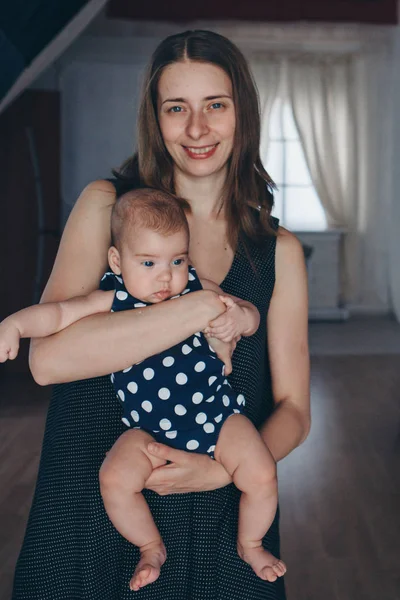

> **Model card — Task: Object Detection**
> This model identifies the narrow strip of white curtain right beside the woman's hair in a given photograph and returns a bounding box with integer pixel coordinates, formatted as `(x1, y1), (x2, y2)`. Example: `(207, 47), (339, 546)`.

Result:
(249, 54), (282, 162)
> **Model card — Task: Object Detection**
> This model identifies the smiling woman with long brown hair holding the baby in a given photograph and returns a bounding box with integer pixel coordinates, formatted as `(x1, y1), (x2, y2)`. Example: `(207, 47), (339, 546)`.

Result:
(13, 31), (310, 600)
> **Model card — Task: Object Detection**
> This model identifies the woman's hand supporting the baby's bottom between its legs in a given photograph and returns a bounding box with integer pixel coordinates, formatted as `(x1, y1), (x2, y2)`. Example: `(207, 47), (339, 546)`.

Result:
(145, 442), (232, 496)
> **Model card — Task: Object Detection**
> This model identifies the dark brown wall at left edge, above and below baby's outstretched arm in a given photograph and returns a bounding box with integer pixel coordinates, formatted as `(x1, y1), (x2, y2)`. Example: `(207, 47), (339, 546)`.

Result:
(0, 90), (61, 375)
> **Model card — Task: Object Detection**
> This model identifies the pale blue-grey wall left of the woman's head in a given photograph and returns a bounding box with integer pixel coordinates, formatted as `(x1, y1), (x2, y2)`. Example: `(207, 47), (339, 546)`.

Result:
(59, 37), (162, 220)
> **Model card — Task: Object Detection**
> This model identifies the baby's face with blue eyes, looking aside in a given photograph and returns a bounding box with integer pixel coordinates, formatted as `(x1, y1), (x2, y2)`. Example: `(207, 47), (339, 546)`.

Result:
(120, 228), (189, 304)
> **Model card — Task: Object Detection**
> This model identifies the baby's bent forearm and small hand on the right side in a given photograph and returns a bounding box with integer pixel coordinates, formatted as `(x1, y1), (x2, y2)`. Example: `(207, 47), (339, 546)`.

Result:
(201, 279), (260, 342)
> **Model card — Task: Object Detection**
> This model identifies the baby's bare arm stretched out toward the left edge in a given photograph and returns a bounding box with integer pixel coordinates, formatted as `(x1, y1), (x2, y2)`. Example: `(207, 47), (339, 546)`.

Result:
(0, 290), (114, 362)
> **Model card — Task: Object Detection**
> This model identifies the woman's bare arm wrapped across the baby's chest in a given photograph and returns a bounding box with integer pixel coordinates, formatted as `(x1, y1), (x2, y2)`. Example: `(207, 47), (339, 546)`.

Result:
(30, 181), (225, 385)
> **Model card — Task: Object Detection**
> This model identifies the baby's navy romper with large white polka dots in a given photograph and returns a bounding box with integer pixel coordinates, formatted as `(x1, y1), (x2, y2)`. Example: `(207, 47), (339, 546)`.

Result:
(101, 267), (245, 457)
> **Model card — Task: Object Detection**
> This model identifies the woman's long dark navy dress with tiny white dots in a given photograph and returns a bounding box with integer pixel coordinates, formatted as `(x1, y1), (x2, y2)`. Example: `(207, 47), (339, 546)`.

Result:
(12, 186), (285, 600)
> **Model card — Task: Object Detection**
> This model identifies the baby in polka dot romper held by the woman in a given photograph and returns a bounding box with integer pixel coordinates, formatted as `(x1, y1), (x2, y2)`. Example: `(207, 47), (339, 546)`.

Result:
(0, 189), (286, 591)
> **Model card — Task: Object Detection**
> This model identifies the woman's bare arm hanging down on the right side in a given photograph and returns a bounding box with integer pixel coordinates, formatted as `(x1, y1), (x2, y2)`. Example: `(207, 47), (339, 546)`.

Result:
(261, 228), (311, 461)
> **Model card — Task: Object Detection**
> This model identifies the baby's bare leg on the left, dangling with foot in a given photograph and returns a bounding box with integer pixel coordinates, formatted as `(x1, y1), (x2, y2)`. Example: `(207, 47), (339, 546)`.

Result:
(100, 429), (166, 591)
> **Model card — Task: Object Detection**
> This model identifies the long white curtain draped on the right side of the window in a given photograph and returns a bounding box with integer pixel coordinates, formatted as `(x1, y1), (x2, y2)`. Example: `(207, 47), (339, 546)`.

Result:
(287, 53), (389, 310)
